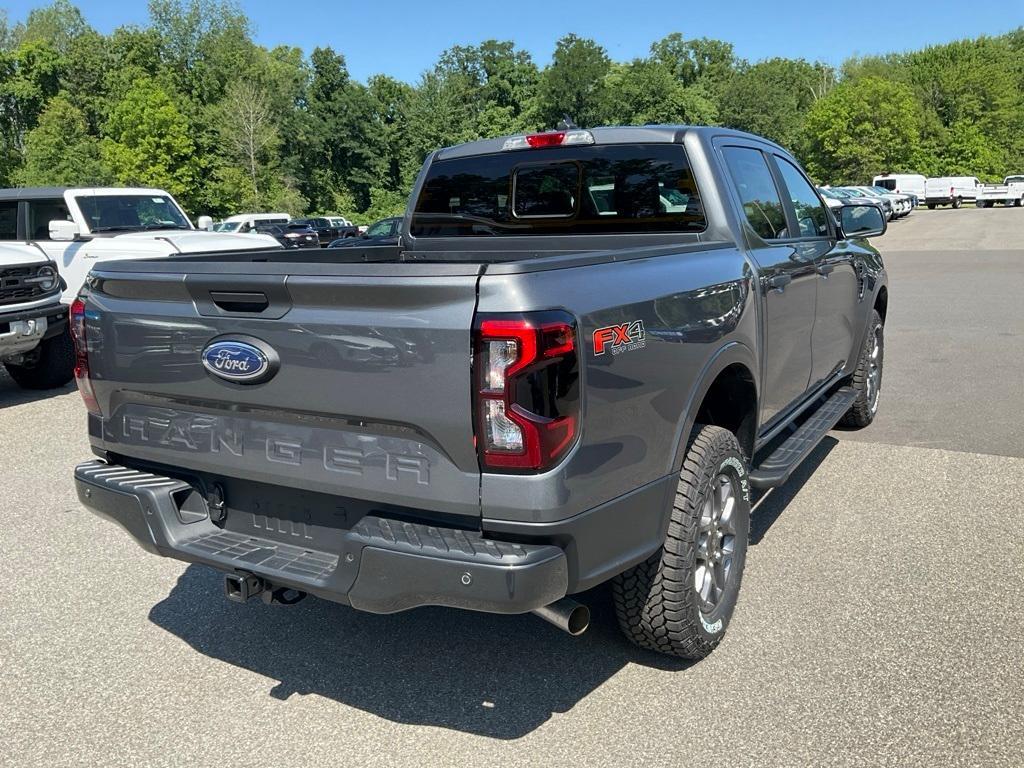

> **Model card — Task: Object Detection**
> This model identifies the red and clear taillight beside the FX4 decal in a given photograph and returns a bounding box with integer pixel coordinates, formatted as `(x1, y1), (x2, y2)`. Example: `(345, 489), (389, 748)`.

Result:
(475, 312), (580, 471)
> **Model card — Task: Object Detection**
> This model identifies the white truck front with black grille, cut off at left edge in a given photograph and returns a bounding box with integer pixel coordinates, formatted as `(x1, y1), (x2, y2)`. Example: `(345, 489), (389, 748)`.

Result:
(0, 243), (75, 389)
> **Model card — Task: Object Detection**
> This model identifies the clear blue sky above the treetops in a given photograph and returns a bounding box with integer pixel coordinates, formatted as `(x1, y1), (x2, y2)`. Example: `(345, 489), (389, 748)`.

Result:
(3, 0), (1024, 82)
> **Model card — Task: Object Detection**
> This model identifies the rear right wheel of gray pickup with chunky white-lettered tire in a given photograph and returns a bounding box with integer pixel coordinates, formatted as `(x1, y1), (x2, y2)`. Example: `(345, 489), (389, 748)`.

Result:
(611, 426), (751, 658)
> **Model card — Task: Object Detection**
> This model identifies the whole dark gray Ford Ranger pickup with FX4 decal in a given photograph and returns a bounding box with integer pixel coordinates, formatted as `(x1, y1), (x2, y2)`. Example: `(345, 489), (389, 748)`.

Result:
(71, 126), (888, 657)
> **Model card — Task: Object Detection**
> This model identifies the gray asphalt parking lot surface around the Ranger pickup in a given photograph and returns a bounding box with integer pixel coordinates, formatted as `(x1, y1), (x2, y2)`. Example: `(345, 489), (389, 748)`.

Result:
(0, 209), (1024, 766)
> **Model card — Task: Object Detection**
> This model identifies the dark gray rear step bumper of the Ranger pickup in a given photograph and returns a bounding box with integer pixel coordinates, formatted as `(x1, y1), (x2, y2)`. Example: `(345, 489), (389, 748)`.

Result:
(75, 461), (568, 613)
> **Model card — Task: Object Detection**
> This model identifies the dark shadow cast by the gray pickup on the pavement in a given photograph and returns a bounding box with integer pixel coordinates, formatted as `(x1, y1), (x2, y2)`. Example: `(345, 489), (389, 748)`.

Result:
(150, 438), (836, 739)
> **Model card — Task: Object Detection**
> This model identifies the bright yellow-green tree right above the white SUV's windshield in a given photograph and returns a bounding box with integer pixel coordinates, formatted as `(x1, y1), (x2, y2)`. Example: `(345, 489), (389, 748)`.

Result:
(100, 79), (199, 204)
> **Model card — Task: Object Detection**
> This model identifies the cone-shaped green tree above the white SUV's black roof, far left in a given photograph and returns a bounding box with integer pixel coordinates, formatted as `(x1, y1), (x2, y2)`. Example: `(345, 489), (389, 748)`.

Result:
(14, 92), (109, 186)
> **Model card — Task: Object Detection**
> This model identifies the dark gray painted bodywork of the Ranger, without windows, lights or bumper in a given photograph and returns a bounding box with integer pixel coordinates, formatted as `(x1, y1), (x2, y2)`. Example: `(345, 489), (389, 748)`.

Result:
(75, 127), (885, 589)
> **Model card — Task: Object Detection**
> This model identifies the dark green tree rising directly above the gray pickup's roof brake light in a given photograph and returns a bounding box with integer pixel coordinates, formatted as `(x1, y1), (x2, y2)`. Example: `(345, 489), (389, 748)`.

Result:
(537, 35), (611, 128)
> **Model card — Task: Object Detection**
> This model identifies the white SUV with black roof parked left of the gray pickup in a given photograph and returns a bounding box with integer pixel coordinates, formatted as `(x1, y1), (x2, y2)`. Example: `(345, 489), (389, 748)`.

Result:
(0, 187), (281, 304)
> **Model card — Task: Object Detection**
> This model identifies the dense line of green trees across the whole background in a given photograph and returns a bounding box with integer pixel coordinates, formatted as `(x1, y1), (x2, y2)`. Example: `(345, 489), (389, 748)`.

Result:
(0, 0), (1024, 221)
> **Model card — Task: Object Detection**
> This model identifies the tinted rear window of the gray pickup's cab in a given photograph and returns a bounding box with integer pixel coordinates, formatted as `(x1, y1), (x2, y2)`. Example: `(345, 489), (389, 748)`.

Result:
(412, 144), (707, 238)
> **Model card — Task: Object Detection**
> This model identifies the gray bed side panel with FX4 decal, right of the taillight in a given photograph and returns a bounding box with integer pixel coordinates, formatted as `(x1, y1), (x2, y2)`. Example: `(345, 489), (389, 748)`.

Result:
(477, 245), (758, 522)
